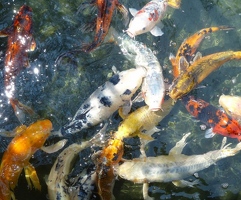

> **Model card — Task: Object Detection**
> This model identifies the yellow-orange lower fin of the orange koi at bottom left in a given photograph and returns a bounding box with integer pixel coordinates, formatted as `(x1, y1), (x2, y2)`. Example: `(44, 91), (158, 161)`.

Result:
(24, 163), (41, 191)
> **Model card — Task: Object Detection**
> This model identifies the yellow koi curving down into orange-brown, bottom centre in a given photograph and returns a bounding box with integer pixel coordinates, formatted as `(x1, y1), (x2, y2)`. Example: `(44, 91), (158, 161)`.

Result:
(96, 99), (172, 200)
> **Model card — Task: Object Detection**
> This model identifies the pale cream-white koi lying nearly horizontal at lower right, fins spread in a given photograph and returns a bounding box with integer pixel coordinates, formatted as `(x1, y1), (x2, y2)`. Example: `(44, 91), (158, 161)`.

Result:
(116, 133), (241, 198)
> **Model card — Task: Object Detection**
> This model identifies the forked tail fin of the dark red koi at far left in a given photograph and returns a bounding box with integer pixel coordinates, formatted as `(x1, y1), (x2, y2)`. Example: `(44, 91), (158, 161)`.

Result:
(10, 99), (35, 124)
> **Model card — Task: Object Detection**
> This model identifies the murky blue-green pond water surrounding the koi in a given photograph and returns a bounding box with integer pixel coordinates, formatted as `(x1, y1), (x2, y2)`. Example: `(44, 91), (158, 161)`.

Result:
(0, 0), (241, 200)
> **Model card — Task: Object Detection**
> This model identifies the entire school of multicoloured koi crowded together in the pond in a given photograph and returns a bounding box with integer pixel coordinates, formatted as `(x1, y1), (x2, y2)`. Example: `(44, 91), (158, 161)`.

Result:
(0, 0), (241, 200)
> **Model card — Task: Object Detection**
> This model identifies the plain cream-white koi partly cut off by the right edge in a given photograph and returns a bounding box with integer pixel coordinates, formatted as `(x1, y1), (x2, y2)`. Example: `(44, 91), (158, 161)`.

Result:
(219, 94), (241, 121)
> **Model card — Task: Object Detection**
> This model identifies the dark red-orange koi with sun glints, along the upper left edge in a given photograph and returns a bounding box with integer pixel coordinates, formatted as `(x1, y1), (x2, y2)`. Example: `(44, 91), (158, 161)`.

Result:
(0, 5), (36, 122)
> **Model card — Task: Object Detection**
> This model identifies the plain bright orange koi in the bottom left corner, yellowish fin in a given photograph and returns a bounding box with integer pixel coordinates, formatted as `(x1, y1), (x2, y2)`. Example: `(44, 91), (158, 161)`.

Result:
(0, 120), (52, 200)
